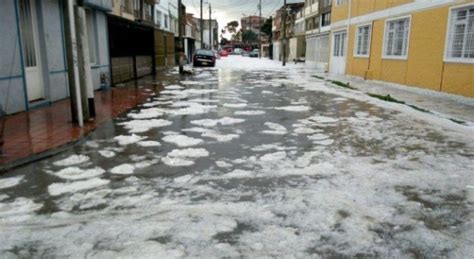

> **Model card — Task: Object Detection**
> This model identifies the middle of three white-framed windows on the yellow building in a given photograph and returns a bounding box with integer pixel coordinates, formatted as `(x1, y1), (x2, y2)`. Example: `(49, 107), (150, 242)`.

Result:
(383, 17), (410, 59)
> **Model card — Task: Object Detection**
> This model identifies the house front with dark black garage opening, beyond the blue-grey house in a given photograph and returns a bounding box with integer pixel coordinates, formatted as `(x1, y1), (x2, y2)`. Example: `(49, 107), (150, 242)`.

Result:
(108, 0), (177, 84)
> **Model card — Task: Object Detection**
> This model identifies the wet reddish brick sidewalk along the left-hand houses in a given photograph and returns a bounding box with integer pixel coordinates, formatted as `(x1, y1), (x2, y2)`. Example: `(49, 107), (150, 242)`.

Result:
(0, 82), (159, 172)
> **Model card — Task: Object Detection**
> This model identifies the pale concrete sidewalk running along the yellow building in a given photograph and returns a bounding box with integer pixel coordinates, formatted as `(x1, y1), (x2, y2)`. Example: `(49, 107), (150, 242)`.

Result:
(317, 73), (474, 125)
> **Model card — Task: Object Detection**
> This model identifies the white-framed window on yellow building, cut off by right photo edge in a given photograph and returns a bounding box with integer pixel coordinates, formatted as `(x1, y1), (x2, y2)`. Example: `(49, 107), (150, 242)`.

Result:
(446, 5), (474, 63)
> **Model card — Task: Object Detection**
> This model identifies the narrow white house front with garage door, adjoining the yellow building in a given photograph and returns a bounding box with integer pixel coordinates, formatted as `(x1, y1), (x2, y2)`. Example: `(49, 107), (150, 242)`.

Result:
(304, 0), (332, 70)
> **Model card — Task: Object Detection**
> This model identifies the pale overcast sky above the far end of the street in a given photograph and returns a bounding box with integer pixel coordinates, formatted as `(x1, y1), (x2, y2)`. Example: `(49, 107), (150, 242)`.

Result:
(183, 0), (304, 36)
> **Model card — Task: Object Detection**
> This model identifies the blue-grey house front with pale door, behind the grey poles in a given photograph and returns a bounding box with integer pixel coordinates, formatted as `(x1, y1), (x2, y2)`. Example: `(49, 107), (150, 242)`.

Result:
(0, 0), (112, 116)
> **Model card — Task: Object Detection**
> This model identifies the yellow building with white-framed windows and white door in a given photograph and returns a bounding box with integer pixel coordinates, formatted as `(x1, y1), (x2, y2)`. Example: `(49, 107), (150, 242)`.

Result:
(330, 0), (474, 97)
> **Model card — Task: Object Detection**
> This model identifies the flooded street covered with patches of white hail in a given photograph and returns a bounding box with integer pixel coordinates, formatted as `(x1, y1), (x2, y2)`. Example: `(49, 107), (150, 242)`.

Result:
(0, 56), (474, 258)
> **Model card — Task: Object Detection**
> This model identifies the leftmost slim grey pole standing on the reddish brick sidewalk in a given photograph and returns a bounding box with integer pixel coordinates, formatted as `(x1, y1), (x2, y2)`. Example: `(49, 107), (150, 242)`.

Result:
(64, 0), (84, 128)
